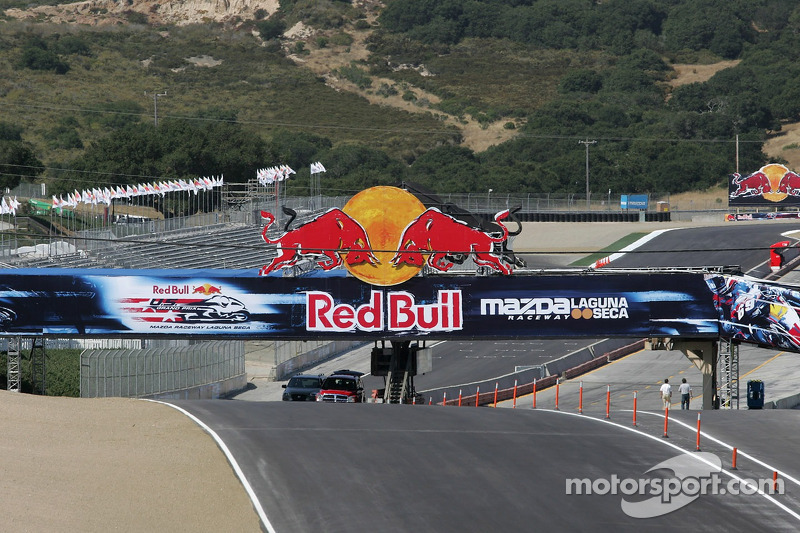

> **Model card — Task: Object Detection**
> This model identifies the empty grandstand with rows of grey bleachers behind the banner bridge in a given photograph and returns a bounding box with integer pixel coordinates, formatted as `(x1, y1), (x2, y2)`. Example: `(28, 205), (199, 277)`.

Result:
(4, 184), (334, 269)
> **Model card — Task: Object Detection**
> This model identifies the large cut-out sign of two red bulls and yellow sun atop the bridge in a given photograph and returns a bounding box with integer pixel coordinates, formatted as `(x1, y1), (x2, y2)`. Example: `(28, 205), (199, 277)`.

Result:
(260, 186), (514, 287)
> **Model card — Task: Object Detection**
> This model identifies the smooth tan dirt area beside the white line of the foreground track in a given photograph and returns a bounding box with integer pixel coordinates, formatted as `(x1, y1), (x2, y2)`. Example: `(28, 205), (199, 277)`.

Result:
(0, 391), (260, 532)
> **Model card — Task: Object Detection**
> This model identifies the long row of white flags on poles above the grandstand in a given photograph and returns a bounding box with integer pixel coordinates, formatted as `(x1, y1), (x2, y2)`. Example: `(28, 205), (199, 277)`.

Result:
(53, 176), (223, 209)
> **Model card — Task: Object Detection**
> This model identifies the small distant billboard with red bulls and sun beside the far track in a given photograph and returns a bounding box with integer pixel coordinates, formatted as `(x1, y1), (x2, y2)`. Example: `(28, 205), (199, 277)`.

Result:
(728, 163), (800, 206)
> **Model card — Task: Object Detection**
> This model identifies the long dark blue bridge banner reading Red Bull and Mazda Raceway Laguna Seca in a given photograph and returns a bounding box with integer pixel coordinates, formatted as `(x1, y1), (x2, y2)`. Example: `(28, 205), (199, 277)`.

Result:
(0, 269), (719, 339)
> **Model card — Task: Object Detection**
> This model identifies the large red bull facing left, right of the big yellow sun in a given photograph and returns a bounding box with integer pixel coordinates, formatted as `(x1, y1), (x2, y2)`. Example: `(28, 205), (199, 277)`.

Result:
(391, 207), (512, 274)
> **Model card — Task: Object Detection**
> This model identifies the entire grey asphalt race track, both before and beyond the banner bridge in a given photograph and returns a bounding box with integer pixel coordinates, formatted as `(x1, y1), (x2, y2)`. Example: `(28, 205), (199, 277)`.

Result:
(171, 223), (800, 533)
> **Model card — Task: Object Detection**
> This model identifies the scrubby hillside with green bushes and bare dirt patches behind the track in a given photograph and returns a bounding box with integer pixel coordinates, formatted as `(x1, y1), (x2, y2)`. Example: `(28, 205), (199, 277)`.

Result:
(0, 0), (800, 194)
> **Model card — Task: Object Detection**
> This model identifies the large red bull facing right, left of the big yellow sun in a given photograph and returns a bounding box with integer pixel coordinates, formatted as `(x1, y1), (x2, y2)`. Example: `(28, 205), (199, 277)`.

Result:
(259, 208), (379, 276)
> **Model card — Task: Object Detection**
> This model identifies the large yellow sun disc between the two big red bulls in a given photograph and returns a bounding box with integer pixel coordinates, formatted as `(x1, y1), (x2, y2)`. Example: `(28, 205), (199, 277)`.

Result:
(342, 186), (432, 286)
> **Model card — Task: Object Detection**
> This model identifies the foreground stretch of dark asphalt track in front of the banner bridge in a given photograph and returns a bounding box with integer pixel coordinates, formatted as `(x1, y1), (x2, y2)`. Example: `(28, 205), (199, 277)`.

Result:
(173, 401), (800, 533)
